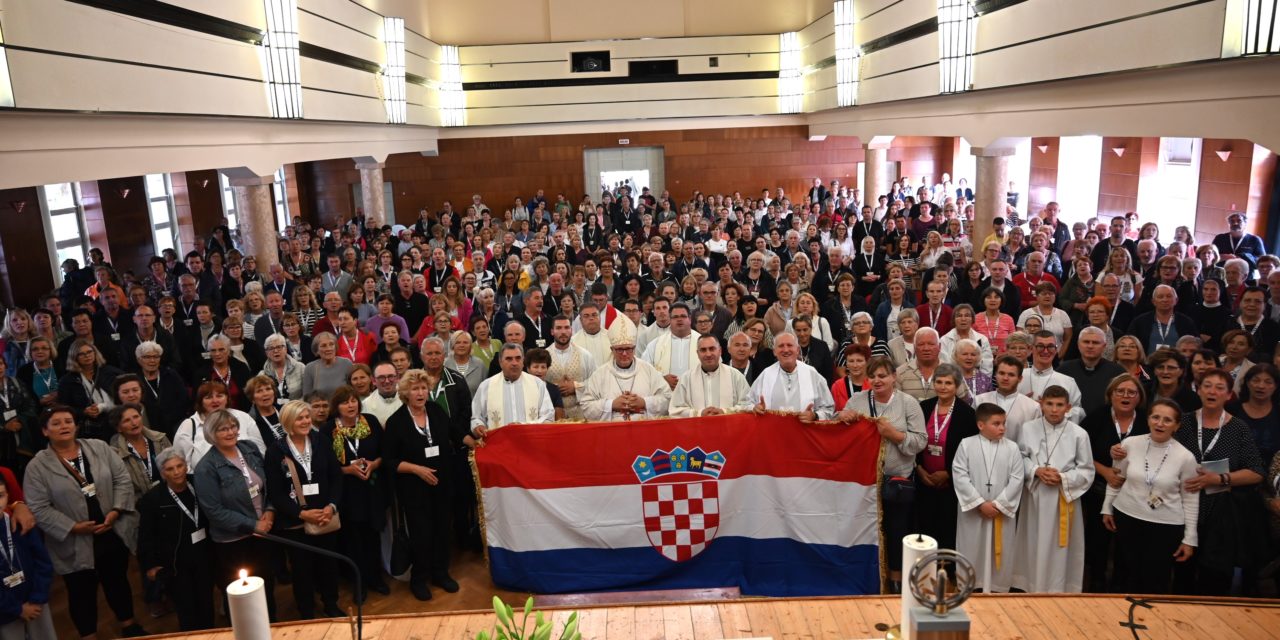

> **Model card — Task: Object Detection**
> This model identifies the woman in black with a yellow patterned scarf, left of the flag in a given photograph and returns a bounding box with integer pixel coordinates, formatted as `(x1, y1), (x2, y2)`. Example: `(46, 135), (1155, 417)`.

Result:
(324, 387), (390, 598)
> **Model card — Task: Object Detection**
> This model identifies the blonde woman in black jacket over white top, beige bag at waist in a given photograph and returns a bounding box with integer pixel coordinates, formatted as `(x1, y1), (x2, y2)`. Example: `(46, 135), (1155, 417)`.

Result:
(265, 401), (344, 620)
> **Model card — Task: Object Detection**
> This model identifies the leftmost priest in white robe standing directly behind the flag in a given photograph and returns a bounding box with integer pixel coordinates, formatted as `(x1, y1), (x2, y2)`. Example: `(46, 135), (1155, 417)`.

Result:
(471, 342), (556, 436)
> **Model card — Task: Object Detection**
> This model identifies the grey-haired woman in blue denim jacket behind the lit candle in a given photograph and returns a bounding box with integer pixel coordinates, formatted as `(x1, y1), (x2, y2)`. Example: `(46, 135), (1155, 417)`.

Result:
(195, 407), (275, 620)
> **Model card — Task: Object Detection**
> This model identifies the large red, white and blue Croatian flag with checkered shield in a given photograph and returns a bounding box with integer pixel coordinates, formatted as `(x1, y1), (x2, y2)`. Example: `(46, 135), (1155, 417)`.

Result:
(476, 413), (881, 596)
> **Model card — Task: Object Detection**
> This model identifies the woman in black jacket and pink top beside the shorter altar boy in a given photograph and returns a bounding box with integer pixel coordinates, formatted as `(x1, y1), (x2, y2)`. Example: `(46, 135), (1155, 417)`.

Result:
(915, 362), (978, 549)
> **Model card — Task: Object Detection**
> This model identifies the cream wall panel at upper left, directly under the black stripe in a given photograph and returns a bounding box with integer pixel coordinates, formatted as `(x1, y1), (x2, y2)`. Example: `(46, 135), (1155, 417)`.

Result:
(4, 0), (262, 78)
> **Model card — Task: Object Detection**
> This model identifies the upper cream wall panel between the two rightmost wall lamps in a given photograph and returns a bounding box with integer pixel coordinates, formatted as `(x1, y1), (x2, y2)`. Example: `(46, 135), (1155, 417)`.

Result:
(977, 0), (1203, 52)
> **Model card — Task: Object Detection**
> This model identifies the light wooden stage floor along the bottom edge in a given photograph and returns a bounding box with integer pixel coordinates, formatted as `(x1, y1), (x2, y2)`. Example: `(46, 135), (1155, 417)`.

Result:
(152, 594), (1280, 640)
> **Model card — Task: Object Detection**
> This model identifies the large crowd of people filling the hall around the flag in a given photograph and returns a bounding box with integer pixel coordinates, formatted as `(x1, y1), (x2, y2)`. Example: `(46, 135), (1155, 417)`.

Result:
(0, 175), (1280, 637)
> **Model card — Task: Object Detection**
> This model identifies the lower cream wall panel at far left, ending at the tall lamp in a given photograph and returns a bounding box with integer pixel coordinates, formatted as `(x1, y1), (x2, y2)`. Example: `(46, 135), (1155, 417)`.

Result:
(9, 50), (271, 118)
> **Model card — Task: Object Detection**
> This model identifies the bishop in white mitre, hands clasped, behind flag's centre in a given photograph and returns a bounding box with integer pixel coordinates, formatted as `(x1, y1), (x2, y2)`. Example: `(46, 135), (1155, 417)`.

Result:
(579, 316), (671, 421)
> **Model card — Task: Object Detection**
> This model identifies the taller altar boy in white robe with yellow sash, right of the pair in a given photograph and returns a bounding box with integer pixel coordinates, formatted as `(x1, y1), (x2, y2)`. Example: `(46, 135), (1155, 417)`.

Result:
(1014, 384), (1094, 593)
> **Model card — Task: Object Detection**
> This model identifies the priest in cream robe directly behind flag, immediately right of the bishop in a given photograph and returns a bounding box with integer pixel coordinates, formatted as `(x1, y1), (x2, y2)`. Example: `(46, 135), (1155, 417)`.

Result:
(671, 335), (751, 417)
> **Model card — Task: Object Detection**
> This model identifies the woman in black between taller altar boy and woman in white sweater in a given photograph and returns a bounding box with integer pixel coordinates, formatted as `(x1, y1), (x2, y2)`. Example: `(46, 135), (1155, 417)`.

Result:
(1080, 374), (1147, 593)
